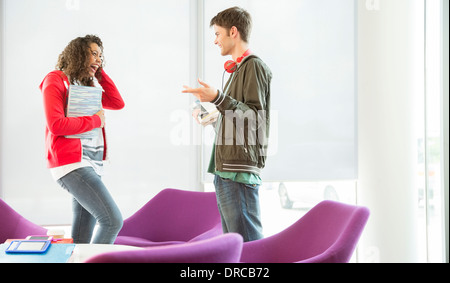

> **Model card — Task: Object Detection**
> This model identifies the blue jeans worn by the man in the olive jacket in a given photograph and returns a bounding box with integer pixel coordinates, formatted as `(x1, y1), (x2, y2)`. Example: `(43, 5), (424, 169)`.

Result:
(214, 175), (263, 242)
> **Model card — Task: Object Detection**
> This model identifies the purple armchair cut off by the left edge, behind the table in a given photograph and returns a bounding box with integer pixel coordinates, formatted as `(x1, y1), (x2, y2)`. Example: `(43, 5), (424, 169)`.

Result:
(0, 199), (47, 243)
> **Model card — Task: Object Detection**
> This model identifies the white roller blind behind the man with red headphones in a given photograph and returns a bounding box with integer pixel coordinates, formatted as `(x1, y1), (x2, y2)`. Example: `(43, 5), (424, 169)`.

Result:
(203, 0), (357, 181)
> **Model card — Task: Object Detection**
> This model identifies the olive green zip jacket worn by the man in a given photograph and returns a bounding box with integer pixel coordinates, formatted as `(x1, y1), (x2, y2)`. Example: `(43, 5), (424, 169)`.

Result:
(212, 55), (272, 175)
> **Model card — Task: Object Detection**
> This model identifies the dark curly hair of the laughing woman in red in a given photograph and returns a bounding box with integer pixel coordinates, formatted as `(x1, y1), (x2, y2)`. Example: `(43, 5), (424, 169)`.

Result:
(56, 35), (103, 86)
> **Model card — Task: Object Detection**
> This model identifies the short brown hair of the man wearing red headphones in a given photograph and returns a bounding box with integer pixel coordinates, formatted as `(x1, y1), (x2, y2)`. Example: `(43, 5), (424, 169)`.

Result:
(210, 7), (252, 43)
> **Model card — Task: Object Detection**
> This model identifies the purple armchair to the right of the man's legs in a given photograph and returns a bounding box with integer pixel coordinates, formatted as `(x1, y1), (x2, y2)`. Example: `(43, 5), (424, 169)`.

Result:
(241, 201), (369, 263)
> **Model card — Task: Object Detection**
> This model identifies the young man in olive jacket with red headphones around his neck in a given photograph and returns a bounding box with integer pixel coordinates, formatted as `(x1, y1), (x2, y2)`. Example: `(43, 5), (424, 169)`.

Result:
(183, 7), (272, 241)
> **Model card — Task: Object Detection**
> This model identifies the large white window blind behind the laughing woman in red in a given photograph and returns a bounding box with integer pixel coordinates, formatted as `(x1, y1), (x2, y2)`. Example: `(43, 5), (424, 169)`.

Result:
(0, 0), (193, 224)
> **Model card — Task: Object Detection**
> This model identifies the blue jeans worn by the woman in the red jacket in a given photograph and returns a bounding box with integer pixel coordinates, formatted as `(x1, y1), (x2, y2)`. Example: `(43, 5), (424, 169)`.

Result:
(57, 167), (123, 244)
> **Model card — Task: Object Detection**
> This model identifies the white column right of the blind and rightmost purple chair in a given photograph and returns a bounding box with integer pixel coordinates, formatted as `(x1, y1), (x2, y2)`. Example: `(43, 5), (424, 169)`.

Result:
(358, 0), (424, 262)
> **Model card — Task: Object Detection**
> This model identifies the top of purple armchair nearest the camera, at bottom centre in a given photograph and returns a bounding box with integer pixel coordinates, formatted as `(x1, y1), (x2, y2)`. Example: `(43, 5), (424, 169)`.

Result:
(85, 233), (243, 263)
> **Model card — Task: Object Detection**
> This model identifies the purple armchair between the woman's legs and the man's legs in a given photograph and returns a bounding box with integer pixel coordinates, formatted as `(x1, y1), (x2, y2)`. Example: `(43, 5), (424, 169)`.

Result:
(115, 189), (223, 247)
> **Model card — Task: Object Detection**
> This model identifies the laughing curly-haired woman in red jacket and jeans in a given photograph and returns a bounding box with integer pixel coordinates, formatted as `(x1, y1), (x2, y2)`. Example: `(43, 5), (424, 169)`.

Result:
(40, 35), (124, 244)
